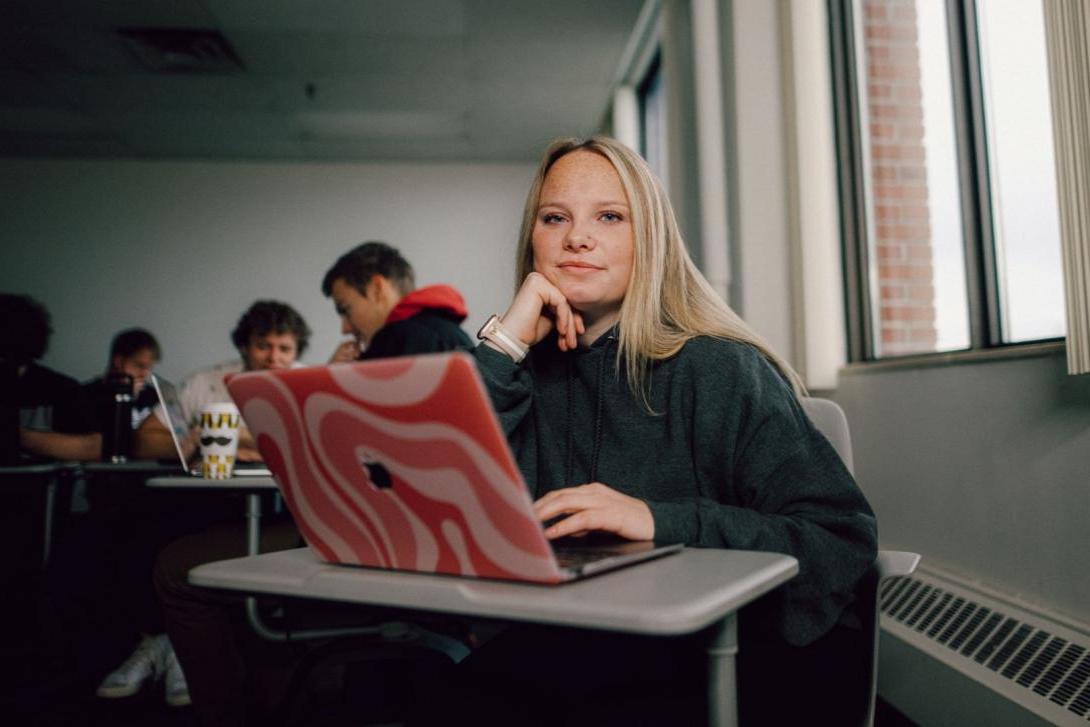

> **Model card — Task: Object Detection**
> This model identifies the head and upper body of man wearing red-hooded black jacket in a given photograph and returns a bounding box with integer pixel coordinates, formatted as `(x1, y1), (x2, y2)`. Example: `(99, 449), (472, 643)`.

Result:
(322, 242), (472, 363)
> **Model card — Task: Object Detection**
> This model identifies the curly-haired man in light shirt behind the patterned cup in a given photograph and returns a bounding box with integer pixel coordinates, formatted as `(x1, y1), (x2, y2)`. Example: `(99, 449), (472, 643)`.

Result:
(133, 301), (311, 461)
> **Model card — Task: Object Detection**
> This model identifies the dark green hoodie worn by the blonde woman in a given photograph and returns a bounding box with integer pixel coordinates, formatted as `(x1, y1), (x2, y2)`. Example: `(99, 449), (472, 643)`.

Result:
(476, 331), (877, 645)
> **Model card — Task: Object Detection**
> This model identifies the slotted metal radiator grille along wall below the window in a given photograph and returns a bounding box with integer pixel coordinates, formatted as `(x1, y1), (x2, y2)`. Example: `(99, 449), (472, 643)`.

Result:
(879, 572), (1090, 725)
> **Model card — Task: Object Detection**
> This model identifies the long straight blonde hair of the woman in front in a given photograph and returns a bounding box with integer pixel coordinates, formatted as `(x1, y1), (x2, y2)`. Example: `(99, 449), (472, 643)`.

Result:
(516, 136), (804, 409)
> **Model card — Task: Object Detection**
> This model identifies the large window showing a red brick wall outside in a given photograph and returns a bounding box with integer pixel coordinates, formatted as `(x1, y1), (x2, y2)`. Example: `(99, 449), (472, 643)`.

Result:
(829, 0), (1064, 361)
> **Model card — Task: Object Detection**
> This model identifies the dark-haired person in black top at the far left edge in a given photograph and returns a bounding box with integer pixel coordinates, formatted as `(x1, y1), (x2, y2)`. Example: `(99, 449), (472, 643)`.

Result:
(0, 293), (101, 464)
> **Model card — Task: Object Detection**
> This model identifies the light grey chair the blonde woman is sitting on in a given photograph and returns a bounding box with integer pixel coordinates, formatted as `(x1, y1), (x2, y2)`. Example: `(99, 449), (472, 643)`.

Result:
(802, 397), (920, 727)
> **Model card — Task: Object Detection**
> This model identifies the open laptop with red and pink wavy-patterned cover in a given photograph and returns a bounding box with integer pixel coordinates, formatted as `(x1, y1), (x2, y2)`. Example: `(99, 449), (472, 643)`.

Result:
(227, 352), (681, 583)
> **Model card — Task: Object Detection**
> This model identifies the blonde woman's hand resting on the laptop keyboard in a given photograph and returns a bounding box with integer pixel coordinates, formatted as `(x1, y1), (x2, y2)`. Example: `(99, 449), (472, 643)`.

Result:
(534, 482), (655, 541)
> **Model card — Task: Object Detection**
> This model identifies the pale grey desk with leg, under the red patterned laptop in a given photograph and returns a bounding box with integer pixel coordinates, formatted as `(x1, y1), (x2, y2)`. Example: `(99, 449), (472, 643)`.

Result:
(190, 548), (799, 726)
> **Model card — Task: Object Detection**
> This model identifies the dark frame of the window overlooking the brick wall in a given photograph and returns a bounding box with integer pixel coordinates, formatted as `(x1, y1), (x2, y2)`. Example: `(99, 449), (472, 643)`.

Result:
(827, 0), (1065, 364)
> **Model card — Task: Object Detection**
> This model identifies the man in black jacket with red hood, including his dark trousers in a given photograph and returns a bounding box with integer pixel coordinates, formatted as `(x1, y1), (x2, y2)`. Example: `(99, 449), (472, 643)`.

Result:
(155, 242), (471, 727)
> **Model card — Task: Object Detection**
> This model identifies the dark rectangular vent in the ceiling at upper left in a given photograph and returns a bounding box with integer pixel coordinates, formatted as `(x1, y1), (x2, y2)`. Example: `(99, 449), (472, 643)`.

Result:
(118, 27), (242, 74)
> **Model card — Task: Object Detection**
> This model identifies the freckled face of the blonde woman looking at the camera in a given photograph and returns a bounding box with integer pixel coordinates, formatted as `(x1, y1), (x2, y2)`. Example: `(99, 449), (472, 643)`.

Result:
(532, 149), (633, 323)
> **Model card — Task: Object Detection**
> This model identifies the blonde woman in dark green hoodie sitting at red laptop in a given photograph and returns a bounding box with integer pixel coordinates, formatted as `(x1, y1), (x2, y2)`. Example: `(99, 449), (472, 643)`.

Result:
(412, 137), (876, 725)
